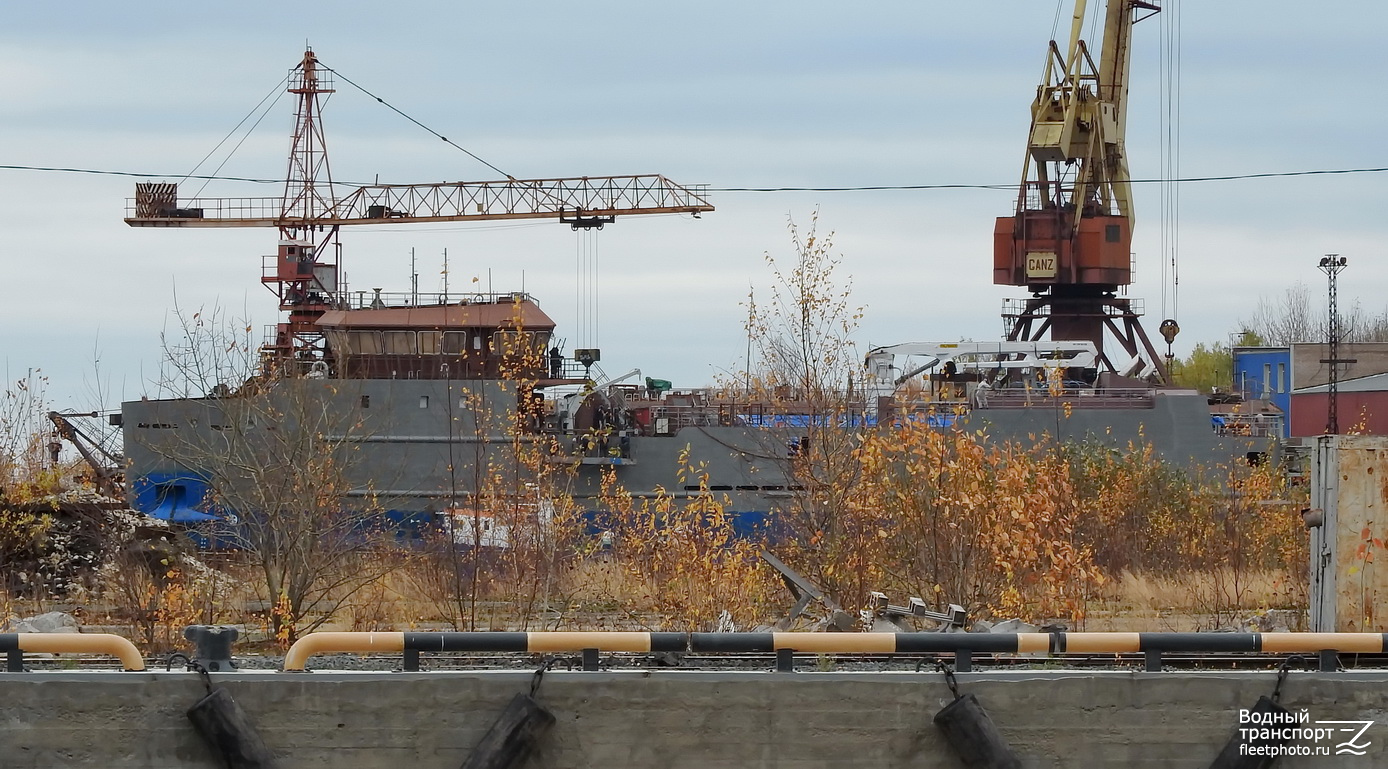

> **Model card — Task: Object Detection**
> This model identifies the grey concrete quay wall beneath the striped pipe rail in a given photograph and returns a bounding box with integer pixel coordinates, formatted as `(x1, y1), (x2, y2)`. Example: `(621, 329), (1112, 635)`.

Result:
(0, 670), (1388, 769)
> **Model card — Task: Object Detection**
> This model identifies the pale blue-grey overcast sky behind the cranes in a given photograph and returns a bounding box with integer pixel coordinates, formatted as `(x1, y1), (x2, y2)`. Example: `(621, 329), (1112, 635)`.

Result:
(0, 0), (1388, 408)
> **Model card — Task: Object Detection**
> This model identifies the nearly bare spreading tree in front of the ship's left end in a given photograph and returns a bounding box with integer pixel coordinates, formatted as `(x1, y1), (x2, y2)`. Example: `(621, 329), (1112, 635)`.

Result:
(136, 302), (393, 641)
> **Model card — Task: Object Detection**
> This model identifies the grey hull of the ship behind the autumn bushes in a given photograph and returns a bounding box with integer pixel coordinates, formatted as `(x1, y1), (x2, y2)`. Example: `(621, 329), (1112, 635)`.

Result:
(122, 379), (1270, 526)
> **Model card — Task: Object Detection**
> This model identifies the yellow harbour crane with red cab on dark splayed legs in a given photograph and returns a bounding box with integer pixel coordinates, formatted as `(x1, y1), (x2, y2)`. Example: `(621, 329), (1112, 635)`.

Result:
(992, 0), (1178, 383)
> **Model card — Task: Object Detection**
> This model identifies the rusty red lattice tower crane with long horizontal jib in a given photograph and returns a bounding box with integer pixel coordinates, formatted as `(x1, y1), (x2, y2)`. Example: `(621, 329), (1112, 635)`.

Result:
(125, 50), (713, 369)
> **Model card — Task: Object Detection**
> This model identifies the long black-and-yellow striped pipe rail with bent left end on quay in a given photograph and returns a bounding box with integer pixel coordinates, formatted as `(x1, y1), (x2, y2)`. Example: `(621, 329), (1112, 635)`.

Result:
(283, 632), (1388, 672)
